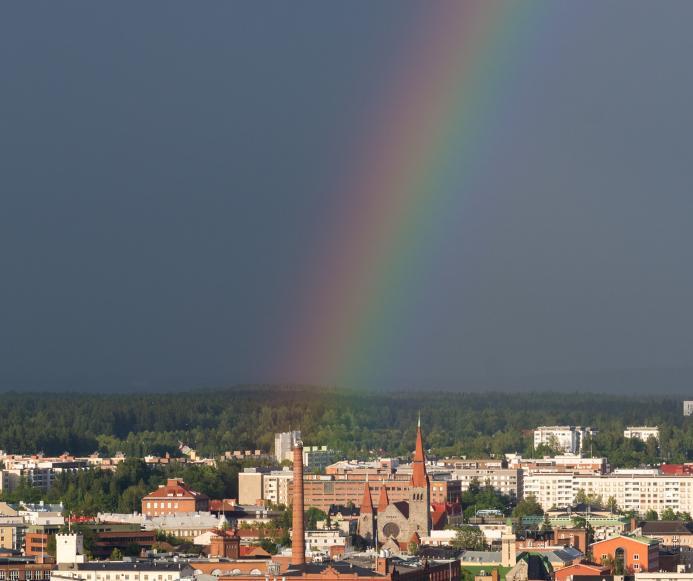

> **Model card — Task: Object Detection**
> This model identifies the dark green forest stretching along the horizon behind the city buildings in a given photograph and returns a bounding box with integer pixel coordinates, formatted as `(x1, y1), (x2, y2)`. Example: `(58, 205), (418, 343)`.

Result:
(0, 386), (693, 467)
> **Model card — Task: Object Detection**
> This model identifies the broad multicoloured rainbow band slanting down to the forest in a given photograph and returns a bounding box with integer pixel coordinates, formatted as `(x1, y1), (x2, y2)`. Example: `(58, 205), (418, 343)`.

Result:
(278, 0), (547, 387)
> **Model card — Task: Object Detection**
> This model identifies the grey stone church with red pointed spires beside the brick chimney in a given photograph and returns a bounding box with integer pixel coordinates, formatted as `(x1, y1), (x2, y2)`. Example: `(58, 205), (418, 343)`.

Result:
(358, 420), (431, 550)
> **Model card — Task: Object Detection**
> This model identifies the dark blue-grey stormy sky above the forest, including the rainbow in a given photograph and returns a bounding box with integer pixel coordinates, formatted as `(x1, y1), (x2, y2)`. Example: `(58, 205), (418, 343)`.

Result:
(0, 0), (693, 392)
